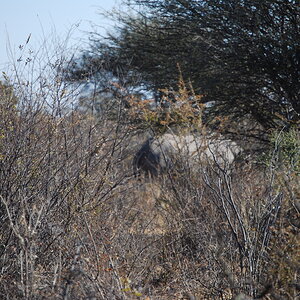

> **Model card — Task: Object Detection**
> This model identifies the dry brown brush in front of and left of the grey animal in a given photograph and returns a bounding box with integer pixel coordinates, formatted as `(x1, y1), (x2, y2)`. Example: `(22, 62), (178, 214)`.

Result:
(0, 41), (299, 300)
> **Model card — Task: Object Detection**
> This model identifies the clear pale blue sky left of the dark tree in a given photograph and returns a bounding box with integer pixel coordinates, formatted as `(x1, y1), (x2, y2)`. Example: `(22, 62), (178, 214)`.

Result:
(0, 0), (121, 70)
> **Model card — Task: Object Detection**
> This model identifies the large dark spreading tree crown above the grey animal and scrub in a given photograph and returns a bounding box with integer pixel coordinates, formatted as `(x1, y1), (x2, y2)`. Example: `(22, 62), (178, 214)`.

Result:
(70, 0), (300, 128)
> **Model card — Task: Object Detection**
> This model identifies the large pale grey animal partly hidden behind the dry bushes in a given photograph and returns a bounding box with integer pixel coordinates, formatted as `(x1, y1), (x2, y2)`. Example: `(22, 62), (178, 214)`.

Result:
(133, 133), (242, 176)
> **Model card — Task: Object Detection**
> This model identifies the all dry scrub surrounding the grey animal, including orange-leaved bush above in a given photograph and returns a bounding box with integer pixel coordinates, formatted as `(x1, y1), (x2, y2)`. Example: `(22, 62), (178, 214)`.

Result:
(0, 1), (300, 300)
